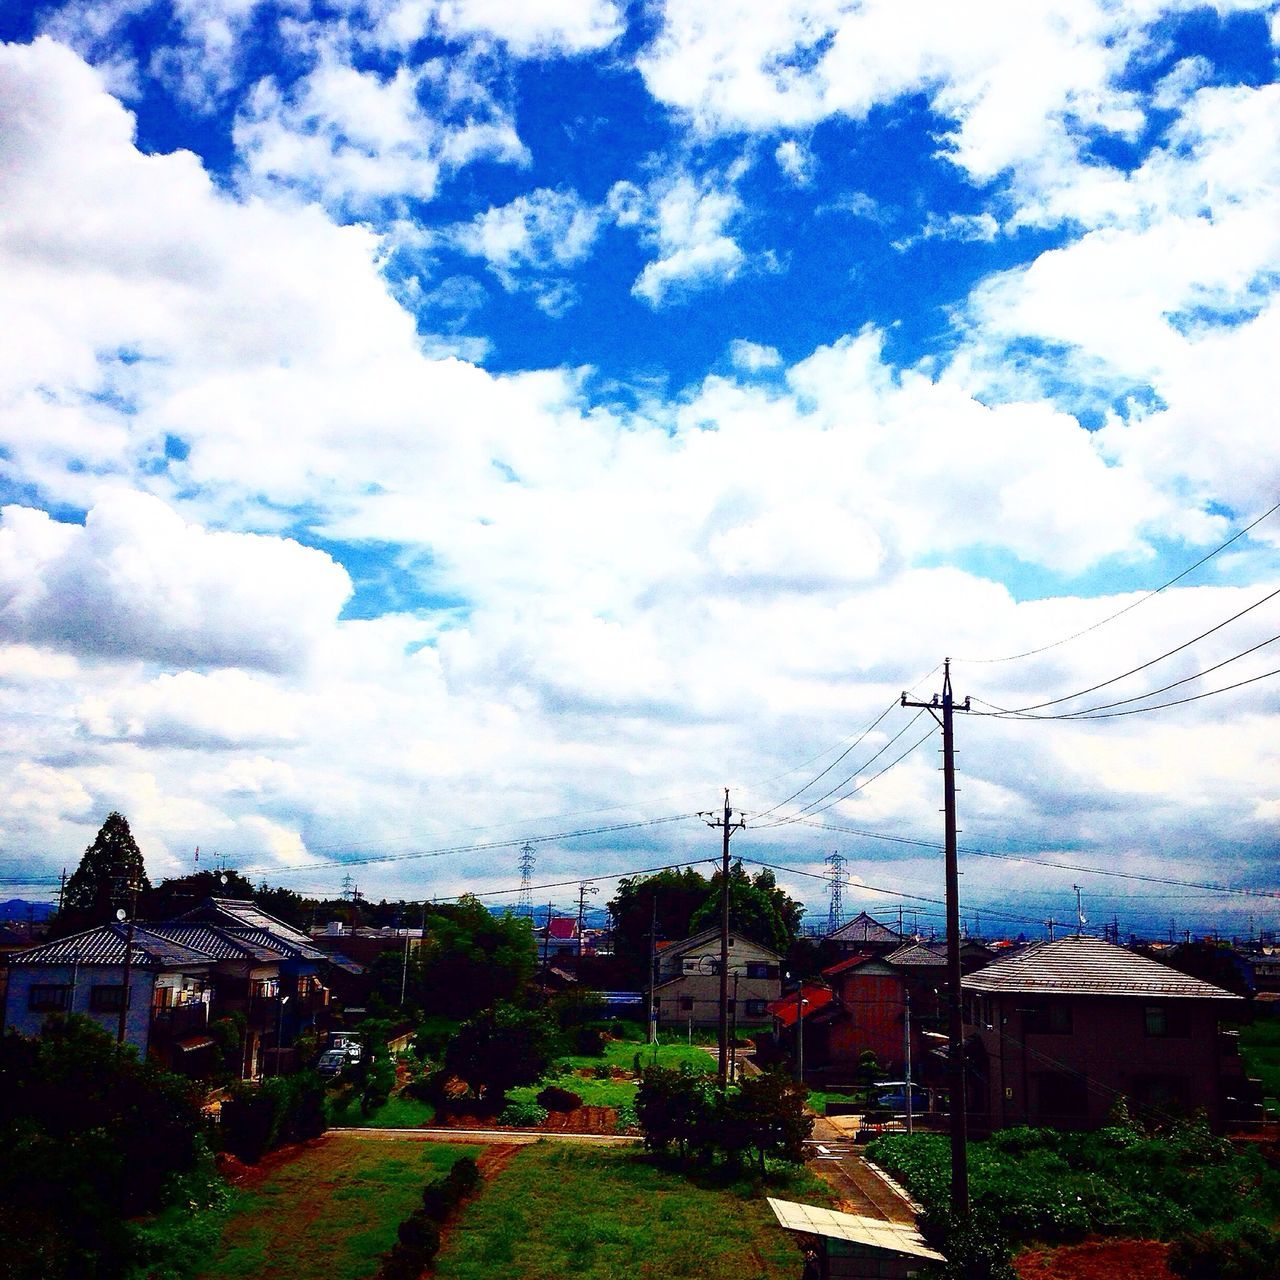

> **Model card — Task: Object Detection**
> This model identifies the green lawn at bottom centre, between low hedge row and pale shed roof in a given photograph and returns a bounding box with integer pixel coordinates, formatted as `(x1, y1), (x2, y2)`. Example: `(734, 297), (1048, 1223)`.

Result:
(435, 1142), (831, 1280)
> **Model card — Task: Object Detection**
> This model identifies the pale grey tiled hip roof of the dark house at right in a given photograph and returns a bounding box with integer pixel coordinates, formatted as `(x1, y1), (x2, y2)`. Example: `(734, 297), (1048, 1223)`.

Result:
(961, 937), (1240, 1000)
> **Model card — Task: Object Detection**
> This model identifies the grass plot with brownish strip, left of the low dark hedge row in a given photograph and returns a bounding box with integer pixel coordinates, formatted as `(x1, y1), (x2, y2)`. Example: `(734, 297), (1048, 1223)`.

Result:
(200, 1133), (479, 1280)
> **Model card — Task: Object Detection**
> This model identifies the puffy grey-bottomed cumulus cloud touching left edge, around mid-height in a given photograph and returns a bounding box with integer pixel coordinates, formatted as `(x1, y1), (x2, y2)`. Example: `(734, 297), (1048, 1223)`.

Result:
(0, 492), (351, 671)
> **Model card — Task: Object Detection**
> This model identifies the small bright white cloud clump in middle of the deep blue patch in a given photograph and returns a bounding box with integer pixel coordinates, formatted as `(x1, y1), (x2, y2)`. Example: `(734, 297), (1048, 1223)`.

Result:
(608, 174), (745, 307)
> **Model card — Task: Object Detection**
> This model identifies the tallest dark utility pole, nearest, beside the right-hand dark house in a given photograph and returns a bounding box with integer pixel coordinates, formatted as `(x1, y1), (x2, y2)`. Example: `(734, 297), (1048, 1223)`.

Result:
(902, 658), (969, 1217)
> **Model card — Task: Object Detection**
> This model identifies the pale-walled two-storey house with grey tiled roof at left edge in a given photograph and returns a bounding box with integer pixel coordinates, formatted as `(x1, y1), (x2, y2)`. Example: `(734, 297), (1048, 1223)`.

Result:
(4, 922), (215, 1075)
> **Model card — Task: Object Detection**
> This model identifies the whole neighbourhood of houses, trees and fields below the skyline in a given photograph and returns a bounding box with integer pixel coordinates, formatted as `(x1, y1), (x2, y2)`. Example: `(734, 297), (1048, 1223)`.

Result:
(0, 814), (1280, 1280)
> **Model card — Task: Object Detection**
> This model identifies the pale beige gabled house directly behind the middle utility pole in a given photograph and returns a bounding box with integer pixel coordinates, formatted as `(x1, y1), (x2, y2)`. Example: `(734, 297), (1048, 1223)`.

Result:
(653, 928), (782, 1027)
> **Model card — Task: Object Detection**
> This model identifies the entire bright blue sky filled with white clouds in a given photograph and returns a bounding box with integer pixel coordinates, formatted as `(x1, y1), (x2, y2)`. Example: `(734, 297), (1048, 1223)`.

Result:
(0, 0), (1280, 937)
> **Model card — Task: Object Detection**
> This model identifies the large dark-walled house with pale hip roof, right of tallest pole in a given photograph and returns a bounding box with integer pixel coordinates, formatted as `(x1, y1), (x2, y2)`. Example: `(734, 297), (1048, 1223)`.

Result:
(961, 936), (1253, 1133)
